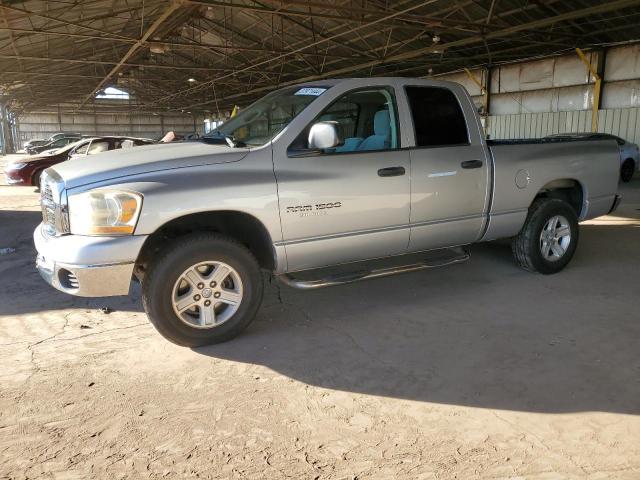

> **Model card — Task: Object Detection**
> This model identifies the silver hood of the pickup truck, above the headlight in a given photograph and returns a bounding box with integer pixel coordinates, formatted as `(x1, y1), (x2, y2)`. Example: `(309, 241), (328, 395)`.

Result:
(54, 142), (249, 188)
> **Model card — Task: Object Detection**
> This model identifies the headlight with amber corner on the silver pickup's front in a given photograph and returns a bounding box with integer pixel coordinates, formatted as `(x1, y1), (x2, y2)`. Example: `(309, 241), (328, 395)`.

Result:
(69, 190), (142, 235)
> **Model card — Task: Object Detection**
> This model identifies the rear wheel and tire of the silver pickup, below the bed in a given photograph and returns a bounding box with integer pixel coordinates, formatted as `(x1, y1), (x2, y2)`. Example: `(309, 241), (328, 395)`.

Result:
(511, 198), (578, 275)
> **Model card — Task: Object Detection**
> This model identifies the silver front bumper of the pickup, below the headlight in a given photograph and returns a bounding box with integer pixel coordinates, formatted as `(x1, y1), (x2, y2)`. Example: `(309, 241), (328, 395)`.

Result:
(33, 225), (147, 297)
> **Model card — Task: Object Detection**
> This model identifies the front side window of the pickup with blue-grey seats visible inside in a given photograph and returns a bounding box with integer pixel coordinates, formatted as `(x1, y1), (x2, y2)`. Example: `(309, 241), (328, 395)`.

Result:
(289, 88), (399, 155)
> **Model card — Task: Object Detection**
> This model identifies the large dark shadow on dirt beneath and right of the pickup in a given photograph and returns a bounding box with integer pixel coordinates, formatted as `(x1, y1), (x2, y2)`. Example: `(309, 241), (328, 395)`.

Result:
(196, 226), (640, 414)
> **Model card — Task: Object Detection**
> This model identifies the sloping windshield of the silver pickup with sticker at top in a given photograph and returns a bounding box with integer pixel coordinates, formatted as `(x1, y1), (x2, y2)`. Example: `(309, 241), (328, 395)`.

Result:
(204, 86), (327, 146)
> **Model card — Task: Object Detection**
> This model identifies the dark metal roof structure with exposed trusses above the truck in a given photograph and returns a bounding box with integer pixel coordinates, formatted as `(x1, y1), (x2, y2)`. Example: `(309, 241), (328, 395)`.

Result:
(0, 0), (640, 113)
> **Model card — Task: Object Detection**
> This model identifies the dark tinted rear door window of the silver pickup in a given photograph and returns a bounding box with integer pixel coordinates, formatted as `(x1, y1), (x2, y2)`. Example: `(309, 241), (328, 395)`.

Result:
(406, 87), (469, 147)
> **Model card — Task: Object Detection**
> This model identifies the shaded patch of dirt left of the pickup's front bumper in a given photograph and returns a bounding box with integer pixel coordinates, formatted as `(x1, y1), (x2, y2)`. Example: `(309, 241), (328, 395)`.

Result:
(0, 210), (142, 316)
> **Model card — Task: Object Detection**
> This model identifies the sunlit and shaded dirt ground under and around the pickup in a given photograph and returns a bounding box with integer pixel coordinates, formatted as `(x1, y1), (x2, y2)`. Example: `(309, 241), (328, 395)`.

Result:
(0, 157), (640, 480)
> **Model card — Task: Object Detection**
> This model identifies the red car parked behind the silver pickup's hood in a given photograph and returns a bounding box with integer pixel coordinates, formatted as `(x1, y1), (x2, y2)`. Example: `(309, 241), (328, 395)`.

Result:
(4, 137), (156, 188)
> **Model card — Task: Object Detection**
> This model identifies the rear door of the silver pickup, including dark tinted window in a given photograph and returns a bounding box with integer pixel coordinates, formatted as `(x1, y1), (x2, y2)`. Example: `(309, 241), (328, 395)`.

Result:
(405, 86), (490, 251)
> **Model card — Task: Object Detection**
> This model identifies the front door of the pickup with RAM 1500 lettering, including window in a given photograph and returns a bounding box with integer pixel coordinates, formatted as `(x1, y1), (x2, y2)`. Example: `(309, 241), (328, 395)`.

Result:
(274, 87), (410, 271)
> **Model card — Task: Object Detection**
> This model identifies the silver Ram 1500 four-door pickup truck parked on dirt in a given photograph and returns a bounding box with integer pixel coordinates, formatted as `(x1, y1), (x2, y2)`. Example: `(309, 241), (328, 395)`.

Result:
(34, 78), (619, 346)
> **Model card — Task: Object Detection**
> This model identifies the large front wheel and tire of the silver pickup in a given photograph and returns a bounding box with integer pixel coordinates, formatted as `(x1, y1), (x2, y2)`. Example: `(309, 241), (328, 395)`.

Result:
(142, 234), (263, 347)
